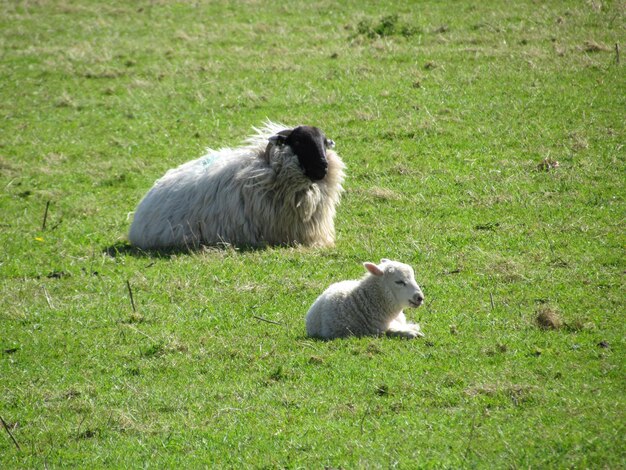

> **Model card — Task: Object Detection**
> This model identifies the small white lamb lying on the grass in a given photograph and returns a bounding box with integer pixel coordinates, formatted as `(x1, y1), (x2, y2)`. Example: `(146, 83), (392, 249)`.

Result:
(306, 259), (424, 339)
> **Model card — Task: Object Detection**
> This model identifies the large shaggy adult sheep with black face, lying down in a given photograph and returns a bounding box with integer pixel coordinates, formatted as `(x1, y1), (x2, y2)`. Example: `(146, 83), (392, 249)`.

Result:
(129, 122), (345, 249)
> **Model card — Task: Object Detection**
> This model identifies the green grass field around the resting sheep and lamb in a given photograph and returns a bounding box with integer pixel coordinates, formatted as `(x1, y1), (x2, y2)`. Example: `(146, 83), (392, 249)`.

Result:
(0, 0), (626, 469)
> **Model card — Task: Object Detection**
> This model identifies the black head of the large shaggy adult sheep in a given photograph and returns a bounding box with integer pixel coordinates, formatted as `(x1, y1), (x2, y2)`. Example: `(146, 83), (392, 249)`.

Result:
(266, 126), (335, 181)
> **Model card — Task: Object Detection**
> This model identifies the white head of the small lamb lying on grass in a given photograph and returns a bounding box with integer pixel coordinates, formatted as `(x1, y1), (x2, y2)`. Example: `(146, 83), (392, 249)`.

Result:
(363, 259), (424, 308)
